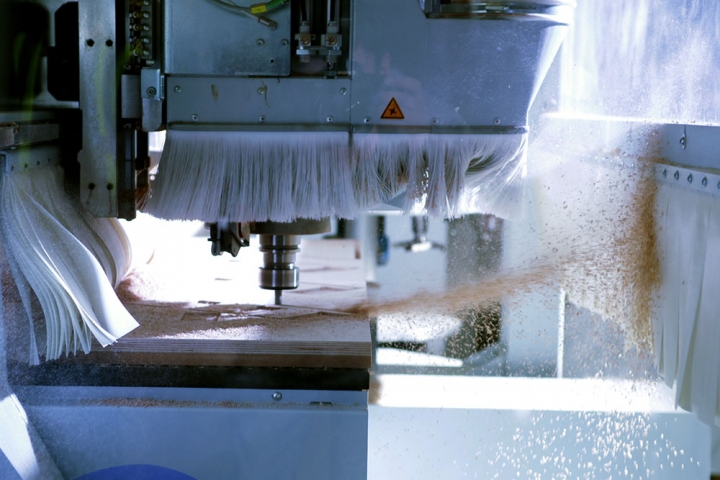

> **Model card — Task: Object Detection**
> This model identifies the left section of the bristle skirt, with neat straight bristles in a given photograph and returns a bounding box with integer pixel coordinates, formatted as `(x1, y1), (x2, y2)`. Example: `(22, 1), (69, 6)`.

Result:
(145, 130), (356, 222)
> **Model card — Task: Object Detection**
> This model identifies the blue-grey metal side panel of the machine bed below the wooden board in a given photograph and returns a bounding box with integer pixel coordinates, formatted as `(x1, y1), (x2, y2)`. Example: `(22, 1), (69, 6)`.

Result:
(19, 387), (368, 480)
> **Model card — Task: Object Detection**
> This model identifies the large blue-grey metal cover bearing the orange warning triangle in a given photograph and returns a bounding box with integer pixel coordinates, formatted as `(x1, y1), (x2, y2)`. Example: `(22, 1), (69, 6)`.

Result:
(352, 0), (567, 127)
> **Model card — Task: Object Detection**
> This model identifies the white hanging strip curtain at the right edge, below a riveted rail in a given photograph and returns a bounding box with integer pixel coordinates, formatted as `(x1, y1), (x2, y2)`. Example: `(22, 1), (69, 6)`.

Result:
(654, 172), (720, 425)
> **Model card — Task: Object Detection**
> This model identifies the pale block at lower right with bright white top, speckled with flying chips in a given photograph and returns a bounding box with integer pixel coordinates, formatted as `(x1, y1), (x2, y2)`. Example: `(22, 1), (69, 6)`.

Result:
(368, 376), (710, 480)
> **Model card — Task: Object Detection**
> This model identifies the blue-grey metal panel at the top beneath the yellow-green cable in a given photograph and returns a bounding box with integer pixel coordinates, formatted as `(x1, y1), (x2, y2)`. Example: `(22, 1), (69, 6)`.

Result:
(165, 0), (292, 76)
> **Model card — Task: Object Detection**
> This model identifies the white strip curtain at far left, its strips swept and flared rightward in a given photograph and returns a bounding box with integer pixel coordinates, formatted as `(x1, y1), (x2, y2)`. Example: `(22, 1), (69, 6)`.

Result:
(0, 155), (138, 364)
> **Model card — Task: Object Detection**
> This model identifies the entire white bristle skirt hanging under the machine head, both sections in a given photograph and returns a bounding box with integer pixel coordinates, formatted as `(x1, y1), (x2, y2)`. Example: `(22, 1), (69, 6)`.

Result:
(144, 130), (526, 222)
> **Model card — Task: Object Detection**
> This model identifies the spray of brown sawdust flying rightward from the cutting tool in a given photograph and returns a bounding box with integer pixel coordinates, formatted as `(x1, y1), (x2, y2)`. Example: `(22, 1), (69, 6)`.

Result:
(354, 146), (660, 353)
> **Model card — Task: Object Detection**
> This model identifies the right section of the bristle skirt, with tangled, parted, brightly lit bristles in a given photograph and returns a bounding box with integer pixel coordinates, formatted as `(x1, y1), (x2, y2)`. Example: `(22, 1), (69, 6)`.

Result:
(353, 133), (527, 218)
